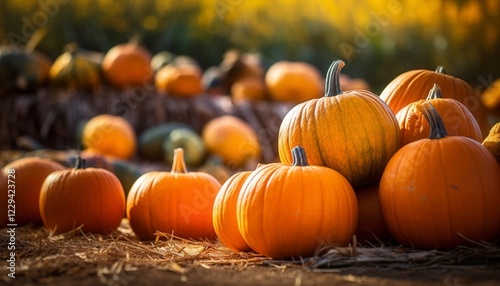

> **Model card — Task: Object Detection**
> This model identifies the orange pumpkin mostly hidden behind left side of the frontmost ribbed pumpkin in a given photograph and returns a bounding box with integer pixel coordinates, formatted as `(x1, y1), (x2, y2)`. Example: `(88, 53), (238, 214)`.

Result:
(213, 171), (252, 252)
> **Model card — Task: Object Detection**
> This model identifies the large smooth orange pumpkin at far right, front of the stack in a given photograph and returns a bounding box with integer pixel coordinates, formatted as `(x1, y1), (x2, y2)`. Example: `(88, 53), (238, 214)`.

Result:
(379, 103), (500, 250)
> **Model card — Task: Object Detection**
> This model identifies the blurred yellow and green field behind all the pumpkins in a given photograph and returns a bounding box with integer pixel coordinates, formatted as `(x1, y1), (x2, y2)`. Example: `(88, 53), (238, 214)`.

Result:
(0, 0), (500, 92)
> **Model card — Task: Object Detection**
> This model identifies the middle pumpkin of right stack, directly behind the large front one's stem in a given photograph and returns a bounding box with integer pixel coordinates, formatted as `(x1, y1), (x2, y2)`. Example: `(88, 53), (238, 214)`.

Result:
(396, 84), (483, 146)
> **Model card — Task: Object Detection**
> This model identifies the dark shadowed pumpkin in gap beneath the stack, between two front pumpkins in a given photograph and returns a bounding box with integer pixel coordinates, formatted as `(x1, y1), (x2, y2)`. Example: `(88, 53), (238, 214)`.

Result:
(355, 182), (391, 244)
